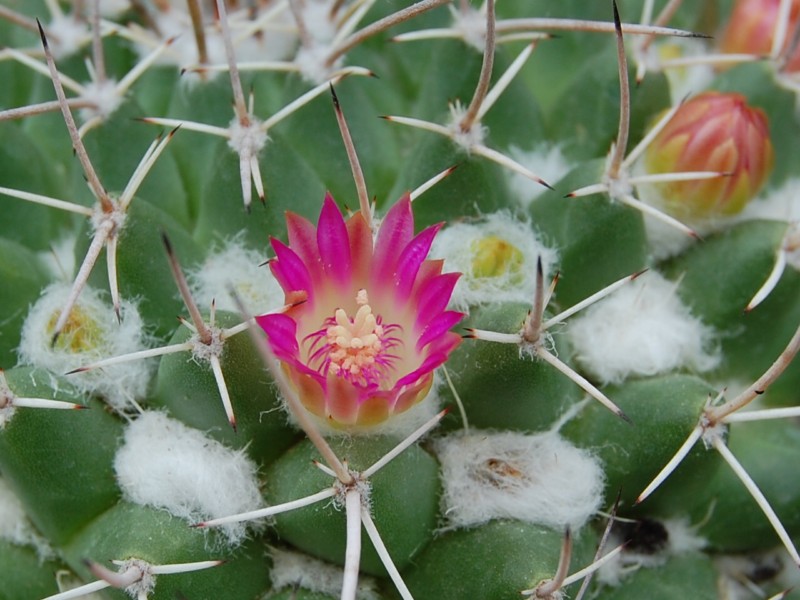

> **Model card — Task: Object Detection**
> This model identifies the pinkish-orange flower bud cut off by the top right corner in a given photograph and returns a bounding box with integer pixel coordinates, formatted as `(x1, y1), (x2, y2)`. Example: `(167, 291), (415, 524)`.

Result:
(720, 0), (800, 72)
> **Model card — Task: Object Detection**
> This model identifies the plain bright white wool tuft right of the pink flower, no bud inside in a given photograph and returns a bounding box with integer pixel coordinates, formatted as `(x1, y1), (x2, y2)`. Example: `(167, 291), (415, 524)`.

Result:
(567, 271), (720, 383)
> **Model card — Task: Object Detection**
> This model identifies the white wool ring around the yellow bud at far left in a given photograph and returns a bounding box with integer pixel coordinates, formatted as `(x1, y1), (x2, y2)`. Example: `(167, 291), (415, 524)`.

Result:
(18, 283), (154, 412)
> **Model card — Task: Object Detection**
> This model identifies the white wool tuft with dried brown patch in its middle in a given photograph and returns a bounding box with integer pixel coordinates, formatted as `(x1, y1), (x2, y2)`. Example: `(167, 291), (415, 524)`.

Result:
(435, 432), (604, 529)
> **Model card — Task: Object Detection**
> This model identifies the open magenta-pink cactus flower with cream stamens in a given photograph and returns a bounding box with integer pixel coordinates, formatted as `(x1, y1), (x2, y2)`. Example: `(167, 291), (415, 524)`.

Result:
(256, 195), (464, 430)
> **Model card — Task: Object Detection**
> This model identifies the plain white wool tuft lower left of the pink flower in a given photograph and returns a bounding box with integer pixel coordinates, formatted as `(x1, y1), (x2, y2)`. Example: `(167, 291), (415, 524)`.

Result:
(114, 412), (264, 545)
